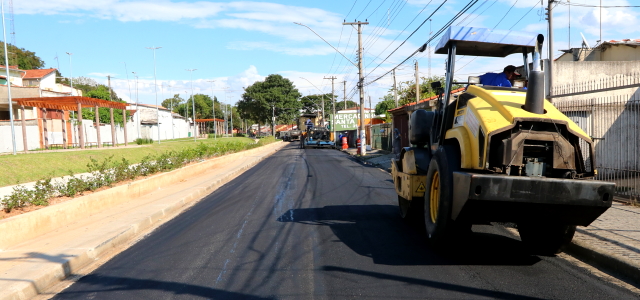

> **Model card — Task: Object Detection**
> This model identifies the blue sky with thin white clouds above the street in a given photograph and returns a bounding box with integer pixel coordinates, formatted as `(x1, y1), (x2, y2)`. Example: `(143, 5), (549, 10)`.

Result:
(11, 0), (640, 106)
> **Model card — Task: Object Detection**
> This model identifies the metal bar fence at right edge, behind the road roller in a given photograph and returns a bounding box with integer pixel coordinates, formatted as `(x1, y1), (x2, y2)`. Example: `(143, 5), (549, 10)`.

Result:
(554, 94), (640, 199)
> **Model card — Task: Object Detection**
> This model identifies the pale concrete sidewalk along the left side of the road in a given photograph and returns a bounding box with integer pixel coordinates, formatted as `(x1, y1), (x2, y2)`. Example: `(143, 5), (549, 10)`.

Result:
(0, 143), (285, 300)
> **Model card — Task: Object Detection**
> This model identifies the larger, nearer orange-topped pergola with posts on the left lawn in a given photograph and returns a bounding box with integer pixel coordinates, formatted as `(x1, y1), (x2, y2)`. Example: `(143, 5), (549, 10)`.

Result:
(13, 96), (127, 152)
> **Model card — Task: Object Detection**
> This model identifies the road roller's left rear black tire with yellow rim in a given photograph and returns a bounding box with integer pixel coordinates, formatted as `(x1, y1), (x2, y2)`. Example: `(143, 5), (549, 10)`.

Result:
(423, 145), (460, 246)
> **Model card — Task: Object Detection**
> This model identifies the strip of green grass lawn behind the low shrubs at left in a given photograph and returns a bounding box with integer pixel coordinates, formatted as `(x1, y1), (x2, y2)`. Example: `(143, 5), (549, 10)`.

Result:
(0, 137), (254, 187)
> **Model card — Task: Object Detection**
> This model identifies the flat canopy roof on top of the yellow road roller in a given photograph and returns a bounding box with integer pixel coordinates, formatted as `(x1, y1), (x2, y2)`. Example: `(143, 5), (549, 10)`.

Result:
(435, 26), (538, 57)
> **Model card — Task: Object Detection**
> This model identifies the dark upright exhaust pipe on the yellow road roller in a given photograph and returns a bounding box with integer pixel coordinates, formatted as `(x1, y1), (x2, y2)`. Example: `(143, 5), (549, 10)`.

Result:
(524, 34), (544, 114)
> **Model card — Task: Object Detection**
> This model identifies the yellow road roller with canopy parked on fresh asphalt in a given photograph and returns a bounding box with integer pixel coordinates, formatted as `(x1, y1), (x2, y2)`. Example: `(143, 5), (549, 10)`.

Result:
(392, 26), (615, 255)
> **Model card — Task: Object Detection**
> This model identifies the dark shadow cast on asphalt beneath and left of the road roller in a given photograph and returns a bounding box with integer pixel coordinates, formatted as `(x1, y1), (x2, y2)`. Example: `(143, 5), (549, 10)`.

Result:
(278, 205), (540, 266)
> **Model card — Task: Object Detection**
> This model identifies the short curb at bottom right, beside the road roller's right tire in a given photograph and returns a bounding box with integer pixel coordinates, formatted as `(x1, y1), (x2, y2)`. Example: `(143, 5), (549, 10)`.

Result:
(564, 237), (640, 285)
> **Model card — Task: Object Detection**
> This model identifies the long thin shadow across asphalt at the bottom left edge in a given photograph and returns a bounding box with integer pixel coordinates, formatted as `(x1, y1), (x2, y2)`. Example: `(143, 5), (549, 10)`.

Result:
(53, 274), (274, 300)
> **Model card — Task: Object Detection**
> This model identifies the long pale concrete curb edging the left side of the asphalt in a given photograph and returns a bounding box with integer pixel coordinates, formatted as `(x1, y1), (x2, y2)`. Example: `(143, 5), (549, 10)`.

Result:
(0, 143), (285, 300)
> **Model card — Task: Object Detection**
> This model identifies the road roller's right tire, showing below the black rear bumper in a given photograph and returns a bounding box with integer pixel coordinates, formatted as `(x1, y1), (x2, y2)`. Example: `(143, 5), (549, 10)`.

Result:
(518, 221), (576, 256)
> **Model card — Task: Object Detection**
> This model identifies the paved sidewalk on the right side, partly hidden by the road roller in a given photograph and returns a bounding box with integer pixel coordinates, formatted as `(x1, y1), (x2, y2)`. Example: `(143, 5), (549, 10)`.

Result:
(341, 148), (640, 286)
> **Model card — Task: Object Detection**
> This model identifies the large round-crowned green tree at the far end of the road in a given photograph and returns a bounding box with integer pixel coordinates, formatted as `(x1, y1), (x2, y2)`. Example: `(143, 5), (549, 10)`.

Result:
(237, 74), (302, 133)
